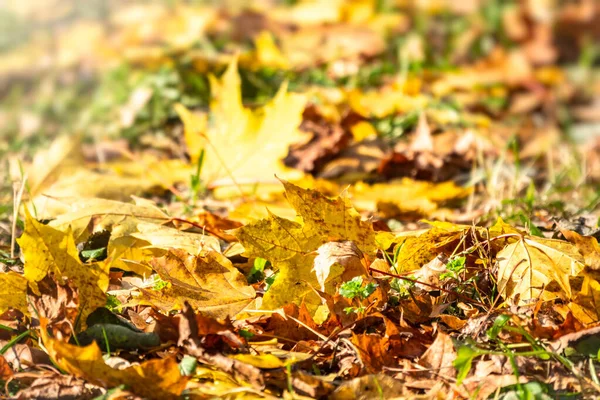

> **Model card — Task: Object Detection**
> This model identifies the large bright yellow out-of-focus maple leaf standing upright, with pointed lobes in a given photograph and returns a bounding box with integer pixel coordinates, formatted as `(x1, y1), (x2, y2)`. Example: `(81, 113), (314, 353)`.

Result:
(176, 59), (306, 186)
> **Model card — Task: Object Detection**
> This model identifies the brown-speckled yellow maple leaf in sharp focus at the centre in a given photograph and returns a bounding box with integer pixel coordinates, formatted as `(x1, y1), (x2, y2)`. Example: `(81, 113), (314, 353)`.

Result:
(234, 181), (377, 312)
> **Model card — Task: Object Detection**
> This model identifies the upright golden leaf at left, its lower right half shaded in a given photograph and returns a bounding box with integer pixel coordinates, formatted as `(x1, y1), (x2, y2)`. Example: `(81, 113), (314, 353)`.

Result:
(18, 212), (110, 321)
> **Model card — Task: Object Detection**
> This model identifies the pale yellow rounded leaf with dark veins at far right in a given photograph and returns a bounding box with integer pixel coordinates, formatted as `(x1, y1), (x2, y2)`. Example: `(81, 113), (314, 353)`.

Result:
(496, 237), (585, 305)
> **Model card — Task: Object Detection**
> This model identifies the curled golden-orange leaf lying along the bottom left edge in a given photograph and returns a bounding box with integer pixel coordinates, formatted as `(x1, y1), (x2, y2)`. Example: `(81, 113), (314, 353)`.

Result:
(40, 328), (187, 400)
